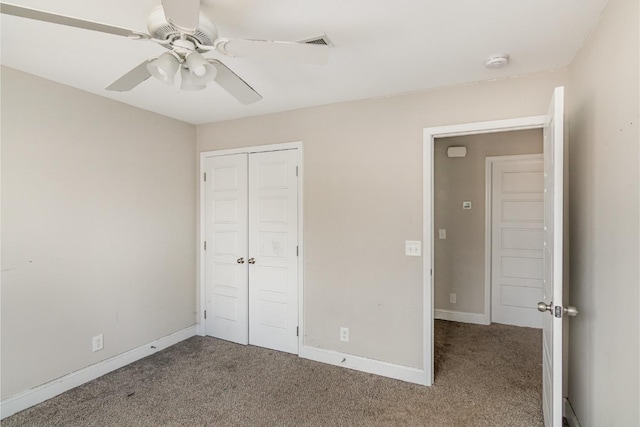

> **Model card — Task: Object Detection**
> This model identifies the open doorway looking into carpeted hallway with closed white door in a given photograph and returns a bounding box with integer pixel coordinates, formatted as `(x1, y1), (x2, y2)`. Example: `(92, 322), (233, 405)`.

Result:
(433, 128), (543, 423)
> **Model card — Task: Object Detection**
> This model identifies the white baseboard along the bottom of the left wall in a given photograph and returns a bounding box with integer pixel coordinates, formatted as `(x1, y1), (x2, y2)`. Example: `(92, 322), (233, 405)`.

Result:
(0, 325), (196, 419)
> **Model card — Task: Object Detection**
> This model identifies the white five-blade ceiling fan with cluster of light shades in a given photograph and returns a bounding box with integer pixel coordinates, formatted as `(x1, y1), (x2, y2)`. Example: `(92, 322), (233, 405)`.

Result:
(0, 0), (328, 104)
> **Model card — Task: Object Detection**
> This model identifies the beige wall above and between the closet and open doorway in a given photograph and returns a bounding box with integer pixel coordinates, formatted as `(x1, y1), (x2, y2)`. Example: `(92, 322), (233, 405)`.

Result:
(197, 72), (566, 368)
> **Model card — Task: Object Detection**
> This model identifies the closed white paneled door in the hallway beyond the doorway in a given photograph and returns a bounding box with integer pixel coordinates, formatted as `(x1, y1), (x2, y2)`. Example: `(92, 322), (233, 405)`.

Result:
(491, 156), (544, 328)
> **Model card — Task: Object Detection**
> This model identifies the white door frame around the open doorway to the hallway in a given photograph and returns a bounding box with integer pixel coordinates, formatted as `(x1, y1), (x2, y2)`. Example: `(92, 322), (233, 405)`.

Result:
(422, 115), (547, 386)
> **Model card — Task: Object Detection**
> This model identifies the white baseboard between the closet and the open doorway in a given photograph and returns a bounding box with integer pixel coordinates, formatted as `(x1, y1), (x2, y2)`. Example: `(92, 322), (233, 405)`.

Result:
(299, 346), (427, 385)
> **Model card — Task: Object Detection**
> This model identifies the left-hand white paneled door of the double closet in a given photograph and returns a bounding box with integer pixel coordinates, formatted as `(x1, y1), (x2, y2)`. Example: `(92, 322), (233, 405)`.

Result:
(204, 154), (249, 344)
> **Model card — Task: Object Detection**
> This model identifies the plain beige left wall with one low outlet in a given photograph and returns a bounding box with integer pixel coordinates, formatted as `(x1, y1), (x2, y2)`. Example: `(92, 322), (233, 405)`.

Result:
(1, 68), (196, 399)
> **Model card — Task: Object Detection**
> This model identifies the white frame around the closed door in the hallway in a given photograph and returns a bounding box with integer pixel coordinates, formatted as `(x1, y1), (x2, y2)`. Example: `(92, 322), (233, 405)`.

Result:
(484, 153), (544, 325)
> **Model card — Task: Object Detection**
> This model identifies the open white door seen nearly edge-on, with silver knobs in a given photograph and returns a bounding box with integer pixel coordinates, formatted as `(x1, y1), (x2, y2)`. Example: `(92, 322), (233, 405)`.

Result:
(539, 87), (564, 427)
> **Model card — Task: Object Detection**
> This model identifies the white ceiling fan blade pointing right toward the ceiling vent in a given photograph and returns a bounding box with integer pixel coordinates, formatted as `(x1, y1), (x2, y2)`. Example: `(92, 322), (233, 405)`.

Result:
(216, 39), (329, 65)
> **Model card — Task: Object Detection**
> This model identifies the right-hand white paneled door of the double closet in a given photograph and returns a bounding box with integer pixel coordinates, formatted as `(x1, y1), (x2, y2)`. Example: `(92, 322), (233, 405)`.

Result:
(248, 150), (298, 354)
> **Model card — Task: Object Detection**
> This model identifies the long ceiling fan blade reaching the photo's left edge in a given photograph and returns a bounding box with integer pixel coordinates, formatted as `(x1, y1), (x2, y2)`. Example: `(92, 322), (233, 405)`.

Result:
(0, 3), (151, 39)
